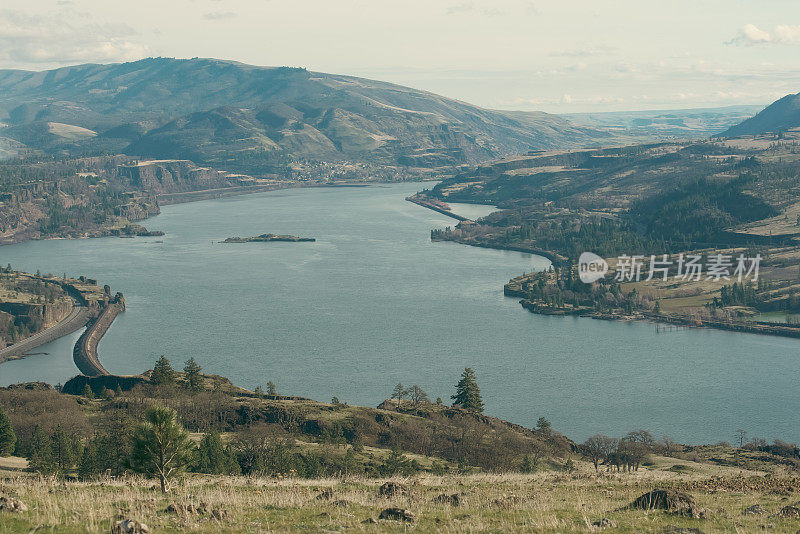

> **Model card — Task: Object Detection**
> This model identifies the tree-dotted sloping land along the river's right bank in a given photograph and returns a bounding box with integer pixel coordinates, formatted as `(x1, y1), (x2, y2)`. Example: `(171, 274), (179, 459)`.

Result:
(422, 132), (800, 337)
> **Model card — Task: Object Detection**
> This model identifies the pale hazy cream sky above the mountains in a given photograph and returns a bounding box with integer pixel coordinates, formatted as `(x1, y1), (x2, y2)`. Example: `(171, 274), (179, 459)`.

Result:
(0, 0), (800, 113)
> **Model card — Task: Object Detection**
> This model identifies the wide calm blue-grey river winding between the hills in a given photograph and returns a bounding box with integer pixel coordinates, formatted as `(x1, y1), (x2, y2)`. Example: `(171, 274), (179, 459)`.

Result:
(0, 184), (800, 443)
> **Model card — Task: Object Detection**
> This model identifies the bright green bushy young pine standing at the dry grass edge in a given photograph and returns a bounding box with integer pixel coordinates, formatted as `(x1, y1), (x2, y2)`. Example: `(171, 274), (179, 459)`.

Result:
(129, 410), (194, 493)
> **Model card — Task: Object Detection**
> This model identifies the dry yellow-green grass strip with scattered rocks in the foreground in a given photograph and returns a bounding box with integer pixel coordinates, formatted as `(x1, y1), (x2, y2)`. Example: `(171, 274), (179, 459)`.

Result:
(0, 457), (800, 534)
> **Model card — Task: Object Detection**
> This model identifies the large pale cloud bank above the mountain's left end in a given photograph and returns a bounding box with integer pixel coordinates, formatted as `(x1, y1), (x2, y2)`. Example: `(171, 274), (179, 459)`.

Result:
(0, 10), (149, 67)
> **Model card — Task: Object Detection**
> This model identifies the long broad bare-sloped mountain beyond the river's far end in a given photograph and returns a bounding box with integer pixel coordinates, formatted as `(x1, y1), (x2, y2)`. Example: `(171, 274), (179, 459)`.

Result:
(0, 58), (612, 167)
